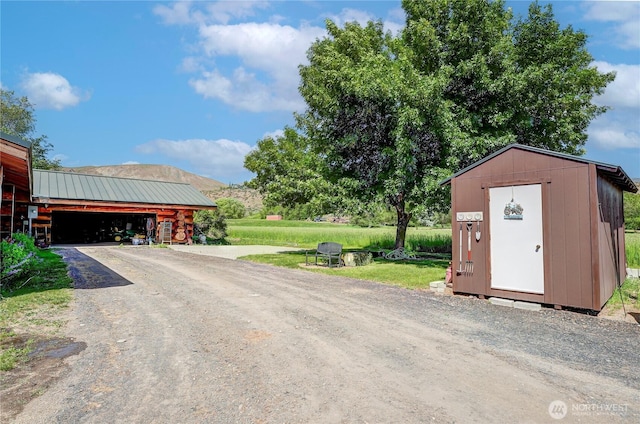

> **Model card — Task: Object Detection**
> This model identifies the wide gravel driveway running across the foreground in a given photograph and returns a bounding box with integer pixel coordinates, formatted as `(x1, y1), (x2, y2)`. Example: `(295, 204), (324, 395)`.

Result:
(17, 247), (640, 424)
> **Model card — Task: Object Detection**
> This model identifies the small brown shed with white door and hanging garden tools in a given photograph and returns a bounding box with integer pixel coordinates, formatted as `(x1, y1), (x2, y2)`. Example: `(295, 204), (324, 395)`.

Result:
(443, 144), (638, 311)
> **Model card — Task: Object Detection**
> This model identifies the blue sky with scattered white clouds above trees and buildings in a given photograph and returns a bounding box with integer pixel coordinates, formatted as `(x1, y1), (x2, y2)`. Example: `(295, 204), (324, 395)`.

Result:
(0, 0), (640, 183)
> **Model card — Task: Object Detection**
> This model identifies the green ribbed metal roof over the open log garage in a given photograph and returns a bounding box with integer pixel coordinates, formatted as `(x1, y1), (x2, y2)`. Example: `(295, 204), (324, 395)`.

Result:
(33, 169), (216, 206)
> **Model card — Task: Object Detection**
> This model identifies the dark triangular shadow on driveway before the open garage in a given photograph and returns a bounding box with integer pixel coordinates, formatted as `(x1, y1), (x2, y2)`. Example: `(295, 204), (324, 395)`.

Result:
(56, 247), (133, 289)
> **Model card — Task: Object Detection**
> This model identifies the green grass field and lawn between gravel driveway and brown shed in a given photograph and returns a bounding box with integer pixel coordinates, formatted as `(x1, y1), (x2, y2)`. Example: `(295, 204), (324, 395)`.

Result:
(227, 219), (451, 289)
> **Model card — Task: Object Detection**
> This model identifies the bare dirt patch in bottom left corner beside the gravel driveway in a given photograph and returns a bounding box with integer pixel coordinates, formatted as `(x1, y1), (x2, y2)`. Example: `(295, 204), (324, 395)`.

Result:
(0, 329), (87, 422)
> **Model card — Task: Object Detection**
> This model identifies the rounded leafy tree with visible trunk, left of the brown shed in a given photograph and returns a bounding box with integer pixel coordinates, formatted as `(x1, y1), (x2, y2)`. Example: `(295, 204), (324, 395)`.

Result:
(298, 21), (451, 247)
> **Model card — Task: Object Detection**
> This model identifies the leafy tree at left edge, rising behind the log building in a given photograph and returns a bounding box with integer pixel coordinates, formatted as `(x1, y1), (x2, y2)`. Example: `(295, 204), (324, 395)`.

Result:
(0, 88), (60, 169)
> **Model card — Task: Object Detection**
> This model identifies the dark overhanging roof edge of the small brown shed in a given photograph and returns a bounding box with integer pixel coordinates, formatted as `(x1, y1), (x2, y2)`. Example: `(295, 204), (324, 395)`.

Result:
(440, 144), (638, 193)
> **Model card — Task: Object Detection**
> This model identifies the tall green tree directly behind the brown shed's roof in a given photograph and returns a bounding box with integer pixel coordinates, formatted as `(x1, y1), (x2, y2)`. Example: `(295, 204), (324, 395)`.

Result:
(403, 0), (614, 168)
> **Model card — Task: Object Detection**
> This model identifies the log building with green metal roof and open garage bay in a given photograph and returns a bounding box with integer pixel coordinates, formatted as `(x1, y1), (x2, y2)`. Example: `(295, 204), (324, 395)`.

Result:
(0, 133), (216, 245)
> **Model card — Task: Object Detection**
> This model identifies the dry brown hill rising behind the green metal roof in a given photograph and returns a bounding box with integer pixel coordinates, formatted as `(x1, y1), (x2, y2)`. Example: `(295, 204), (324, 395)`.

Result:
(63, 164), (227, 191)
